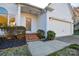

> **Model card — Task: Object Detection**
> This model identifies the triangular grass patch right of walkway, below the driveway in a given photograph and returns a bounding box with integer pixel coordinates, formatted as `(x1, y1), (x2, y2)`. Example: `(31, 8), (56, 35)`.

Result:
(48, 44), (79, 56)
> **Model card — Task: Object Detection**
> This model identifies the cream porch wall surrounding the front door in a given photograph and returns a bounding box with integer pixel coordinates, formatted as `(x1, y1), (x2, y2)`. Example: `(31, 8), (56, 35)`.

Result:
(21, 13), (38, 33)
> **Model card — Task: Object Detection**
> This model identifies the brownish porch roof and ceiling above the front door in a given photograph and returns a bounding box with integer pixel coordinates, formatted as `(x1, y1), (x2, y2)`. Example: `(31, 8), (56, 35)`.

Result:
(17, 3), (44, 15)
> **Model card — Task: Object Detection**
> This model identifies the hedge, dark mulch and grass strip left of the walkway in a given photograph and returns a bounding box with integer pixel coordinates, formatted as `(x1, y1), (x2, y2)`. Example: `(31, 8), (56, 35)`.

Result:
(0, 26), (31, 56)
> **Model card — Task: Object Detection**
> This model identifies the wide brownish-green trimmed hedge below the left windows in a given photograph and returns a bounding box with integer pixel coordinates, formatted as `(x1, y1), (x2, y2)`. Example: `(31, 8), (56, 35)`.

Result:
(0, 26), (26, 39)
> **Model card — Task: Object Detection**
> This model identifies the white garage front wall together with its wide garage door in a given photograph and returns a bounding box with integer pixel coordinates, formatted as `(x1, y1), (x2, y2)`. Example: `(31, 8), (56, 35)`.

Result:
(47, 3), (73, 37)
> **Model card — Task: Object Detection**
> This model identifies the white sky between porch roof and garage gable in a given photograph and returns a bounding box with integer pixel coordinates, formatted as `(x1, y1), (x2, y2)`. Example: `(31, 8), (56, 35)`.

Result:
(27, 0), (53, 8)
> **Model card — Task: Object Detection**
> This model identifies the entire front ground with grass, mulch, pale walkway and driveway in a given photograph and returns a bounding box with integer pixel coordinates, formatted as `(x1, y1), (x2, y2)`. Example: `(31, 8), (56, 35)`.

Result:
(0, 36), (79, 56)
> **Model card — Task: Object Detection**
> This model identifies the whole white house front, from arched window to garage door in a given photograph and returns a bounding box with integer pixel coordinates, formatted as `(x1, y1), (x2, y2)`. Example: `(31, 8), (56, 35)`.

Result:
(0, 3), (73, 37)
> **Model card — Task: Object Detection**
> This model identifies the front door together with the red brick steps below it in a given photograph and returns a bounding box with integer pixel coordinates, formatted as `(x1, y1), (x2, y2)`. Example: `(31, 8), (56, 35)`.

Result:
(26, 17), (39, 41)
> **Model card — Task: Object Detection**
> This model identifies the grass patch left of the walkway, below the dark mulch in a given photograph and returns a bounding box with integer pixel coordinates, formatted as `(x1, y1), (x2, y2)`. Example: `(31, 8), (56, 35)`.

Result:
(0, 45), (31, 56)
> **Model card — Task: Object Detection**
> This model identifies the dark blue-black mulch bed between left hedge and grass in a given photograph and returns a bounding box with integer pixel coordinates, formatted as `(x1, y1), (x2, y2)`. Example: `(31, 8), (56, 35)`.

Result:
(0, 38), (27, 49)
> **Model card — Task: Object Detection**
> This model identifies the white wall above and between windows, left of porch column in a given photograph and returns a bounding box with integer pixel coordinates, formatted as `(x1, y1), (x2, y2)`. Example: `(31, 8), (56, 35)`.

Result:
(0, 3), (18, 25)
